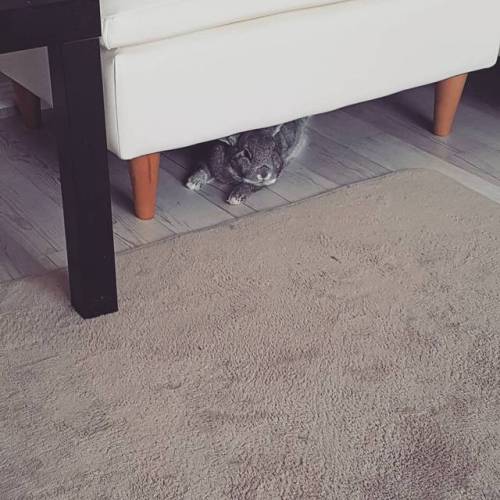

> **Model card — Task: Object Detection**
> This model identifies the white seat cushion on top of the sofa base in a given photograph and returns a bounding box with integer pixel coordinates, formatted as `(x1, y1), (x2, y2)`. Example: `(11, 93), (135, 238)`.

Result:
(101, 0), (349, 49)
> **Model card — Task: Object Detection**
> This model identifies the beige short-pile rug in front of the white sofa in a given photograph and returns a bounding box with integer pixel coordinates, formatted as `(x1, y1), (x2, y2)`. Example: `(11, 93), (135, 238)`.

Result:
(0, 171), (500, 500)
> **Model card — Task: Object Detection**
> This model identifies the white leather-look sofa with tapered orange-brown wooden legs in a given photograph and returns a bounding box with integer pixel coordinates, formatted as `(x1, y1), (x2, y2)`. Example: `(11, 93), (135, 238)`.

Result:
(0, 0), (500, 218)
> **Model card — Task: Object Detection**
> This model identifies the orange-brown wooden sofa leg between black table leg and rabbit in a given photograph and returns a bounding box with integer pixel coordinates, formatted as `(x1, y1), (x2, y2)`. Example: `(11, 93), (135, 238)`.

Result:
(129, 153), (160, 220)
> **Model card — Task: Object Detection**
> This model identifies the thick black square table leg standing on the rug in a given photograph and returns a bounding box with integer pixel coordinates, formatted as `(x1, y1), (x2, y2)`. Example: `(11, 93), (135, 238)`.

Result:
(49, 39), (118, 318)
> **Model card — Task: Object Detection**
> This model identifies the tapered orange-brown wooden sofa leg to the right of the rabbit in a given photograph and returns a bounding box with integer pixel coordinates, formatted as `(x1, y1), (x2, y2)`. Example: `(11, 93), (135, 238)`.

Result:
(434, 74), (468, 137)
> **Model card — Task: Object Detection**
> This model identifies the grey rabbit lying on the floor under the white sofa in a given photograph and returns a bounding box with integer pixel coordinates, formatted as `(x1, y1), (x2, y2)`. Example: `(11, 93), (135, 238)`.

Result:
(186, 117), (308, 205)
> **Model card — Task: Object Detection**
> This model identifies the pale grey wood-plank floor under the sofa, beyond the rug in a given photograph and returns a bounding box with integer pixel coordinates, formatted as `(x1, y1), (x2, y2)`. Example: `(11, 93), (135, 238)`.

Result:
(0, 66), (500, 282)
